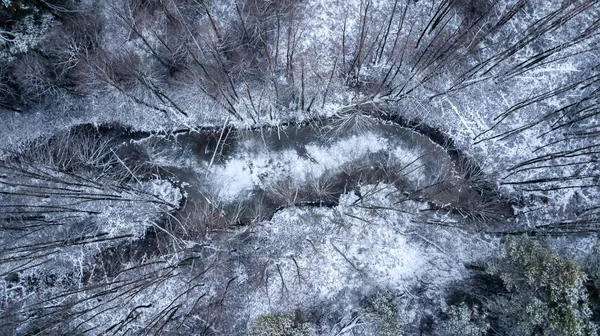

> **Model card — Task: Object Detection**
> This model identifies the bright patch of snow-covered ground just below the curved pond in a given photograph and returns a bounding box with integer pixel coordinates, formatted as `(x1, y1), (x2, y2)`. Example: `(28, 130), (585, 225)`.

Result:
(241, 186), (494, 320)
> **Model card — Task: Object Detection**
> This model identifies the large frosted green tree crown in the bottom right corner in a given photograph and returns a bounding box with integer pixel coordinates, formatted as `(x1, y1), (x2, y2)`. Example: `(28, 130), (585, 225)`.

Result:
(487, 239), (596, 336)
